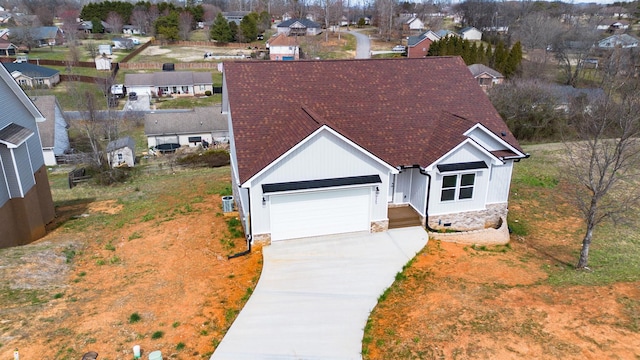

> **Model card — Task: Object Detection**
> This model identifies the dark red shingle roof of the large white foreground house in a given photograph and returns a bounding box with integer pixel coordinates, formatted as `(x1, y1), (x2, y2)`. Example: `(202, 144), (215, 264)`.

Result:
(224, 57), (520, 183)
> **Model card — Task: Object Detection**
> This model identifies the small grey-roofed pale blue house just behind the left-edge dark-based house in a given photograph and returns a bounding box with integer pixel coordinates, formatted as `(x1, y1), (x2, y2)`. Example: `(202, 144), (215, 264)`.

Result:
(33, 95), (70, 166)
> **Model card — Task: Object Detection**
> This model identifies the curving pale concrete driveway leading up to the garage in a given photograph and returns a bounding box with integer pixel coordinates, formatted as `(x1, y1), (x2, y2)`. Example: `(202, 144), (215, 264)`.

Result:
(211, 227), (428, 360)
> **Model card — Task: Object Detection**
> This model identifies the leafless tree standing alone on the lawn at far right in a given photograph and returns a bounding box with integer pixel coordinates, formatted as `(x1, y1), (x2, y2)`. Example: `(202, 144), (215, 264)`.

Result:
(563, 79), (640, 269)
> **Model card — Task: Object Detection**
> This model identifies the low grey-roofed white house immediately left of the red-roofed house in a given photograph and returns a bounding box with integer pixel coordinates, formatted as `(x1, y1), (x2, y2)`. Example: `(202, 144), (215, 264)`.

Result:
(144, 105), (229, 149)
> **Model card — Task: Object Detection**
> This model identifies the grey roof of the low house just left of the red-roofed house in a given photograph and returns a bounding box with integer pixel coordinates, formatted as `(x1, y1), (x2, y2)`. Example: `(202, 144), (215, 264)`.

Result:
(144, 105), (229, 136)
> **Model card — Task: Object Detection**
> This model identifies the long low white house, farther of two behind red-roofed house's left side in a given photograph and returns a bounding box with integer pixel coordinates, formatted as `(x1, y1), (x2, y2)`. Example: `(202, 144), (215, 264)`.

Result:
(124, 71), (213, 96)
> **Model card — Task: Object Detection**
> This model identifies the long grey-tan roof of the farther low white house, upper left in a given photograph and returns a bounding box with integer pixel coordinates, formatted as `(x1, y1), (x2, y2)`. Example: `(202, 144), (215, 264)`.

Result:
(124, 71), (213, 86)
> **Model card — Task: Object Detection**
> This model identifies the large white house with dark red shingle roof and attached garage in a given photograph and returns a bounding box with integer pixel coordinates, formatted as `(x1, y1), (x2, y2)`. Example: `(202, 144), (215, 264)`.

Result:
(222, 57), (528, 242)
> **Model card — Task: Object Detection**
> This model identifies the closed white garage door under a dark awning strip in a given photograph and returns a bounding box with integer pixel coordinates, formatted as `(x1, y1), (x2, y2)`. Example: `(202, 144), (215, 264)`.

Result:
(270, 187), (371, 241)
